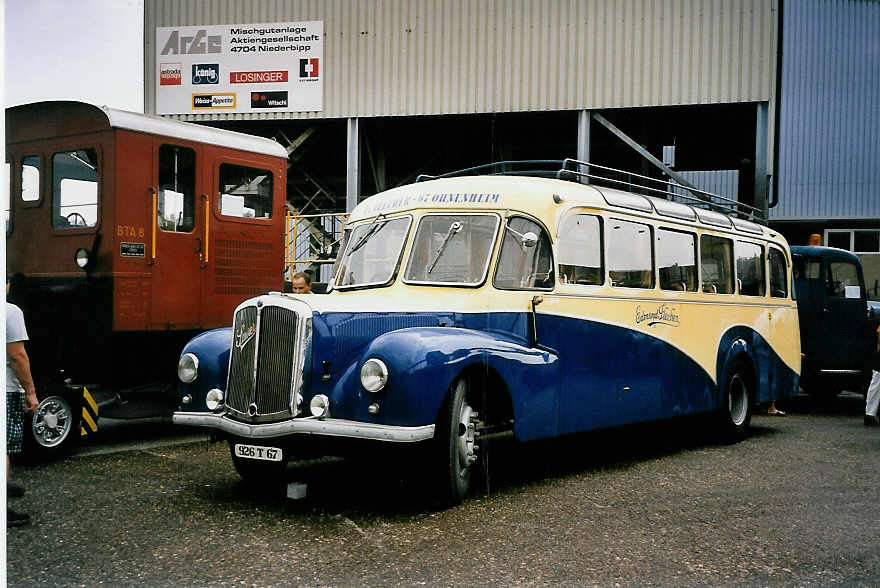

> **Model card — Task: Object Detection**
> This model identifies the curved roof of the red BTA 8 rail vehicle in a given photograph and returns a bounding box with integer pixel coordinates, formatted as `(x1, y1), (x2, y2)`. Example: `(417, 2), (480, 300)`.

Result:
(6, 101), (287, 159)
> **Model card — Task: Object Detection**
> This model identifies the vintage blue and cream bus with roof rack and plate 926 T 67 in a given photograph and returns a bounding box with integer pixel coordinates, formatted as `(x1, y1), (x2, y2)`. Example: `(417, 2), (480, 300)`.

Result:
(174, 160), (800, 504)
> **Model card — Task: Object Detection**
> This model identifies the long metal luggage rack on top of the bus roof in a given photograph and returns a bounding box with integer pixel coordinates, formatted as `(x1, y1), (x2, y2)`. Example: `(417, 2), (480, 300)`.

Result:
(416, 158), (767, 222)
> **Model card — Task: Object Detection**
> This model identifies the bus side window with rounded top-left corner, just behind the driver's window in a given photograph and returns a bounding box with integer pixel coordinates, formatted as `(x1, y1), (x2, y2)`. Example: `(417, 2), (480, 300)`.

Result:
(559, 214), (605, 285)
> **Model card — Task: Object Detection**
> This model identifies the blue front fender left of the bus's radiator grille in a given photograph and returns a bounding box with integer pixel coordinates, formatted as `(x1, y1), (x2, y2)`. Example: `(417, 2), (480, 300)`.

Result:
(177, 327), (232, 411)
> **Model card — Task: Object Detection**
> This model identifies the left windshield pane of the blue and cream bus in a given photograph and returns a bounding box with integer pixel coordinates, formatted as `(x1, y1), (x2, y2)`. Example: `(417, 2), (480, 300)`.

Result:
(336, 216), (412, 289)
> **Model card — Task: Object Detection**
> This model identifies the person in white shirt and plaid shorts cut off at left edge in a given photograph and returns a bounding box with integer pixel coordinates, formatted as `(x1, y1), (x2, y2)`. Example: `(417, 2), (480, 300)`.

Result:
(6, 276), (37, 527)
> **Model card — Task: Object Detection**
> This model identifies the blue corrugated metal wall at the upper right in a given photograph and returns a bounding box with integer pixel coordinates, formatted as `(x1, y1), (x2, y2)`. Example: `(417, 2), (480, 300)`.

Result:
(771, 0), (880, 220)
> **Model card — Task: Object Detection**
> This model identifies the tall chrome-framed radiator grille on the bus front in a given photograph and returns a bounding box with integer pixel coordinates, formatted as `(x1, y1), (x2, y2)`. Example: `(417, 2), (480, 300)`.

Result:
(226, 298), (311, 421)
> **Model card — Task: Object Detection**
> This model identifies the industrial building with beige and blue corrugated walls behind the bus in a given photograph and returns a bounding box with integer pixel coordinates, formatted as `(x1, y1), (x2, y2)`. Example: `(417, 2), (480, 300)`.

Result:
(144, 0), (880, 300)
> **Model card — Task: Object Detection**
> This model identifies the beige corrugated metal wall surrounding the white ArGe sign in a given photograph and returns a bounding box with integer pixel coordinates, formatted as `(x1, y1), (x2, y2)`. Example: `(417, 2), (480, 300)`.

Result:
(144, 0), (776, 120)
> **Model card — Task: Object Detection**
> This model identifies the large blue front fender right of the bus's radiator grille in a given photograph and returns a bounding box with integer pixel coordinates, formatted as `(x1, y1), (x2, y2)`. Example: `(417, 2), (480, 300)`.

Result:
(331, 327), (559, 439)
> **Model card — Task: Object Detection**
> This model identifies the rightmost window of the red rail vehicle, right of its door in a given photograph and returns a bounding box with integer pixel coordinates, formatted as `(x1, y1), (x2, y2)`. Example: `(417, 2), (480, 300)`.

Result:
(220, 163), (272, 219)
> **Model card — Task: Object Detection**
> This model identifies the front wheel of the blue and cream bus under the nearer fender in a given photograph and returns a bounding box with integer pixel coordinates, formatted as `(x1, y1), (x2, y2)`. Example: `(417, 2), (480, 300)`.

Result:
(436, 378), (478, 506)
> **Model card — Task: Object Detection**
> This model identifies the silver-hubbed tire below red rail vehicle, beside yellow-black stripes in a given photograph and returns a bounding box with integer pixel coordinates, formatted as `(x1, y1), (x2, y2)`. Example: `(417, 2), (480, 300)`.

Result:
(24, 394), (80, 459)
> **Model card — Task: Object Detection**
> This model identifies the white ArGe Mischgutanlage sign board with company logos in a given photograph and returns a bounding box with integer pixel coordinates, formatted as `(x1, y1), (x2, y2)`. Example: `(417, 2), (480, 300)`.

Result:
(156, 21), (324, 114)
